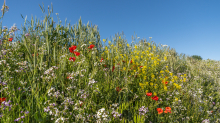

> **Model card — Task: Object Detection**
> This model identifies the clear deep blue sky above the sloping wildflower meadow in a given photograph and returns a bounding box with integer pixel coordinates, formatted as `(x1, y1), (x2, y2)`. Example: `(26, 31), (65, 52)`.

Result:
(0, 0), (220, 60)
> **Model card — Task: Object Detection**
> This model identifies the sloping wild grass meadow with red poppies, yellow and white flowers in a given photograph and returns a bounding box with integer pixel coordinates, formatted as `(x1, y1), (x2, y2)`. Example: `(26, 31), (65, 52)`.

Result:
(0, 1), (220, 123)
